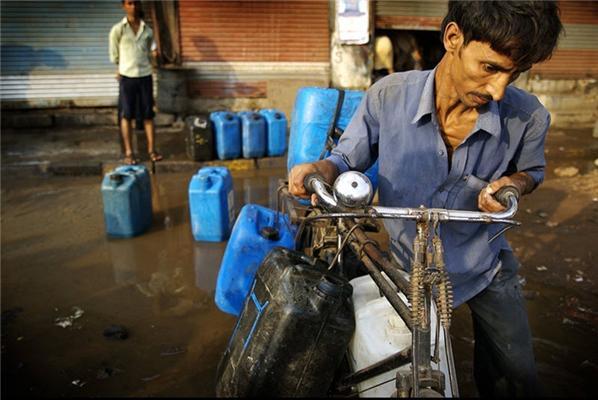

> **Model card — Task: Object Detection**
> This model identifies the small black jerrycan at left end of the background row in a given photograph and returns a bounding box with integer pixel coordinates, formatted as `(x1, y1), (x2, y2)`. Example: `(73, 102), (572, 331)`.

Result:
(185, 115), (214, 161)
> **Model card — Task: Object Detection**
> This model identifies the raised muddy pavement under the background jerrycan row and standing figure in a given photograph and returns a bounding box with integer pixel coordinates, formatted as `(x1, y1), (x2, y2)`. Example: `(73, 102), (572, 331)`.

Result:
(1, 125), (286, 176)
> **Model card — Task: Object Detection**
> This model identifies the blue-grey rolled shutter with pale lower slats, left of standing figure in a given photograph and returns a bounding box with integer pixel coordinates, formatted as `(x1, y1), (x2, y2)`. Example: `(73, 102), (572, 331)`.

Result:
(0, 1), (123, 107)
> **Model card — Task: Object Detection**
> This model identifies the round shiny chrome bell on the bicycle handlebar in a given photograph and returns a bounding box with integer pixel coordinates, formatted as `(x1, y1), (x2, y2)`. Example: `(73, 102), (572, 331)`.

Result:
(333, 171), (374, 208)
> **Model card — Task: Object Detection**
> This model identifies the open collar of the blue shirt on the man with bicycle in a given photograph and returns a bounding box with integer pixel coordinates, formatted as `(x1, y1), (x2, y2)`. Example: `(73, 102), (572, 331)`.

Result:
(411, 68), (500, 136)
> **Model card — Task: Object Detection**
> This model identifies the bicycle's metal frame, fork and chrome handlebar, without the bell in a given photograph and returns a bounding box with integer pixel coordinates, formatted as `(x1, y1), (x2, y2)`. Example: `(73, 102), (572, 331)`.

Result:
(279, 173), (519, 397)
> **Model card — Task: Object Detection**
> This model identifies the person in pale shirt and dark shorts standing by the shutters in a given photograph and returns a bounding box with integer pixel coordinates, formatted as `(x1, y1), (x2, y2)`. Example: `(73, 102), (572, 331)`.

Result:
(109, 0), (162, 164)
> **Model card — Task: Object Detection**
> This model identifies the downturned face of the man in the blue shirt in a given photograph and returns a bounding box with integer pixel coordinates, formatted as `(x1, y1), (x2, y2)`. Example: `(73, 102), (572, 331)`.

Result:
(450, 41), (519, 107)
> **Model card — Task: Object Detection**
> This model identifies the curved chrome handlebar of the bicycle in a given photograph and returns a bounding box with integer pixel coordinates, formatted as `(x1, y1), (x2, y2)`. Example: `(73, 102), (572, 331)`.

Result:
(303, 174), (519, 225)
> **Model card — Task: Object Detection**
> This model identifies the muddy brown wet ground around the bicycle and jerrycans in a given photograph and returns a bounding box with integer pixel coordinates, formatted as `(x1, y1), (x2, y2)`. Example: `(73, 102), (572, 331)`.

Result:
(1, 126), (598, 397)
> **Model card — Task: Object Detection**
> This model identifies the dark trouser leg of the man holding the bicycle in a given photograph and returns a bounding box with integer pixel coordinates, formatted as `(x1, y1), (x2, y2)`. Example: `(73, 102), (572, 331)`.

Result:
(467, 251), (541, 397)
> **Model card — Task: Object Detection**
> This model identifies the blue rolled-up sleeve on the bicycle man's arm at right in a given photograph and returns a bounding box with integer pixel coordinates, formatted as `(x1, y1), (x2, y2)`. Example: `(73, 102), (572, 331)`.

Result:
(510, 108), (550, 188)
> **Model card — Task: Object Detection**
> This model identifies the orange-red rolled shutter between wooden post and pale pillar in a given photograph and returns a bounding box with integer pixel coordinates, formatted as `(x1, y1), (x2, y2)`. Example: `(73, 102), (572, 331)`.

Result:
(179, 0), (330, 62)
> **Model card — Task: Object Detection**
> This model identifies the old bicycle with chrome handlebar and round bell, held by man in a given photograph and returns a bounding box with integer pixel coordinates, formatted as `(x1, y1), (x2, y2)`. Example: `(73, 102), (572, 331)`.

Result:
(279, 171), (519, 397)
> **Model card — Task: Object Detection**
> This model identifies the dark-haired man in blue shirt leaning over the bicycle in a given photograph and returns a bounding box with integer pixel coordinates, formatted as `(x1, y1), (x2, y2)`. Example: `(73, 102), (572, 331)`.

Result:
(289, 1), (562, 396)
